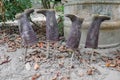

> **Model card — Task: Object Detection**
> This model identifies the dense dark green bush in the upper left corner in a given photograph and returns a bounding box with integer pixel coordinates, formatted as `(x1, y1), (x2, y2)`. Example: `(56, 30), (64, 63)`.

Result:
(0, 0), (32, 21)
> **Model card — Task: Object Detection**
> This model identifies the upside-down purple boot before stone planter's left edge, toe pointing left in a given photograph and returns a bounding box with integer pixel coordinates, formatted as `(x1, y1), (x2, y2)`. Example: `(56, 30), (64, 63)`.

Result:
(65, 14), (83, 49)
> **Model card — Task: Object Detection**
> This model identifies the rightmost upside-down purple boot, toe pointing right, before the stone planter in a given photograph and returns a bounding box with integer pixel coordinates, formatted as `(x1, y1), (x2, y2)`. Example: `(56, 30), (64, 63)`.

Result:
(85, 15), (110, 49)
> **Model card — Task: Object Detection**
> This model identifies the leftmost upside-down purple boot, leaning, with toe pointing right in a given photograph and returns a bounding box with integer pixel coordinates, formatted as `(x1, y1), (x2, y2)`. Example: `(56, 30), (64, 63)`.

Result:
(16, 9), (38, 46)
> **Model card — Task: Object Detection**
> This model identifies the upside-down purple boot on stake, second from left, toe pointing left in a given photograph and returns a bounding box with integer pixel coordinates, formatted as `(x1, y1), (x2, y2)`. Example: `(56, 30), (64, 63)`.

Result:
(37, 9), (59, 41)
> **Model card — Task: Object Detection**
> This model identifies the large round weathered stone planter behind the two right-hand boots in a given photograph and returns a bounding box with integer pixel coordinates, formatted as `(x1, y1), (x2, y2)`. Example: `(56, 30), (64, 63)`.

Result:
(64, 0), (120, 48)
